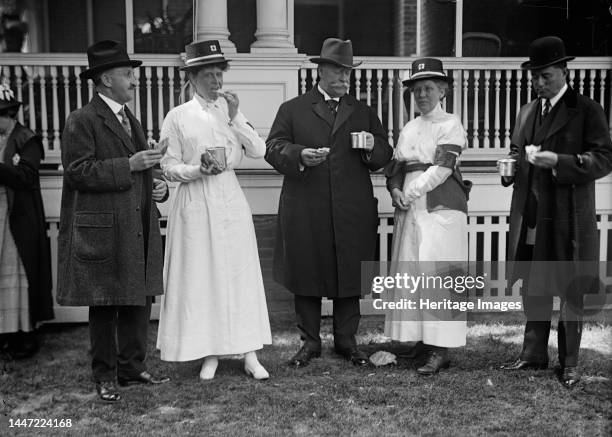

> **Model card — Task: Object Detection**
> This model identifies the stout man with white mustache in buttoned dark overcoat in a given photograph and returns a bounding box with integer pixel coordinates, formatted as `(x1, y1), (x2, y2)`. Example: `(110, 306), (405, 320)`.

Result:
(266, 38), (392, 367)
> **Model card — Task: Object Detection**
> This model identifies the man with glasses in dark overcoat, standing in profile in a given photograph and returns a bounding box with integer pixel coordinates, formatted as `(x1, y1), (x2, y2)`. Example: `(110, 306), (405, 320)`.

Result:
(57, 41), (168, 402)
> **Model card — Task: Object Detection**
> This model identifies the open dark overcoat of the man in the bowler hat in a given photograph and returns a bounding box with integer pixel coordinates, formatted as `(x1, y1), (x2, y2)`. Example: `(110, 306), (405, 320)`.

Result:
(507, 88), (612, 294)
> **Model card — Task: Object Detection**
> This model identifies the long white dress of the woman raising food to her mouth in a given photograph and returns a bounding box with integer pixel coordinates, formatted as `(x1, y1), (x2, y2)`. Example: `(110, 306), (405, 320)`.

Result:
(157, 95), (272, 361)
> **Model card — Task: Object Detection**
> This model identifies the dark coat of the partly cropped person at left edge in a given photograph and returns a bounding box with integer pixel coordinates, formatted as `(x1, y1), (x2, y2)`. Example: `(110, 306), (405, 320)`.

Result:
(0, 123), (53, 323)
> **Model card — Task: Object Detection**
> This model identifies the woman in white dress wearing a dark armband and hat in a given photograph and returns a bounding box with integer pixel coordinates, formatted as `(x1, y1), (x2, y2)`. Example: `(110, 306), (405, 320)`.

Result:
(385, 58), (469, 375)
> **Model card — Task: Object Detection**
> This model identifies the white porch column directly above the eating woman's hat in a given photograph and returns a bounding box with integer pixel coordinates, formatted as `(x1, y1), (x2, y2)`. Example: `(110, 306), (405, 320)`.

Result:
(194, 0), (236, 53)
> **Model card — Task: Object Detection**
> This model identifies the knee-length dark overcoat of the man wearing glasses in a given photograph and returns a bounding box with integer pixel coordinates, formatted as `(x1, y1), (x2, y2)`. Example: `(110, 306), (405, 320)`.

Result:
(57, 94), (163, 306)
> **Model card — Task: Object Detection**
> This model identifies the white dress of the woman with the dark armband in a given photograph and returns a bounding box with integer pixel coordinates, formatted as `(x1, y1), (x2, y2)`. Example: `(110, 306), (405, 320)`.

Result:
(385, 105), (468, 347)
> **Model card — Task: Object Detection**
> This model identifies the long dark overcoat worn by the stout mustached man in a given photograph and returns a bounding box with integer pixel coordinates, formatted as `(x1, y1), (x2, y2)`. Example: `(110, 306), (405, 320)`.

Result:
(266, 88), (393, 297)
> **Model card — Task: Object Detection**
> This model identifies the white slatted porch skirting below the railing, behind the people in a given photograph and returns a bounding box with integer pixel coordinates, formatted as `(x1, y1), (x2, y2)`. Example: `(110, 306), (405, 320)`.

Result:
(43, 171), (612, 322)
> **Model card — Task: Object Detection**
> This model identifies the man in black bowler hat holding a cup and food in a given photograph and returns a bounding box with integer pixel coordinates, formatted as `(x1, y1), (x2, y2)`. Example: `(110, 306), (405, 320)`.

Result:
(502, 36), (612, 388)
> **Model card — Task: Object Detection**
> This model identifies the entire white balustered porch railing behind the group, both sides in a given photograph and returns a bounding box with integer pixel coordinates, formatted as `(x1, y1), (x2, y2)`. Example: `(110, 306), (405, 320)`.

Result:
(0, 53), (612, 163)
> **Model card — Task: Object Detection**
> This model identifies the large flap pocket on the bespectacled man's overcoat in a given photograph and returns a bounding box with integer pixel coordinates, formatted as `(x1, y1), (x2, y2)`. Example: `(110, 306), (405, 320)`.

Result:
(72, 212), (115, 262)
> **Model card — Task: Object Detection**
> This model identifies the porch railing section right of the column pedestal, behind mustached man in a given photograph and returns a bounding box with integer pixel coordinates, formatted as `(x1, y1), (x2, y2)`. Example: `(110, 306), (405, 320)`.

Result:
(300, 58), (612, 160)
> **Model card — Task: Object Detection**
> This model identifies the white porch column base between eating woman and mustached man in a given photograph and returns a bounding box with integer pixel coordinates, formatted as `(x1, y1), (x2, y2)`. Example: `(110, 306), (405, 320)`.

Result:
(251, 0), (297, 53)
